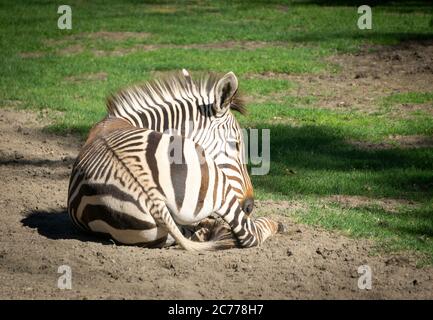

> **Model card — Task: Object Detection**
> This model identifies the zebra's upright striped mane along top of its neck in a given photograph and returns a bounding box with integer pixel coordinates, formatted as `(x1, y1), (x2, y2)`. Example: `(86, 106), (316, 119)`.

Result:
(107, 71), (246, 115)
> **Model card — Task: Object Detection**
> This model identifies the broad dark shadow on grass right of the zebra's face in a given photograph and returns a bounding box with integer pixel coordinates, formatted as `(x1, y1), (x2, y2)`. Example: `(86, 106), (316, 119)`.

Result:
(253, 125), (433, 201)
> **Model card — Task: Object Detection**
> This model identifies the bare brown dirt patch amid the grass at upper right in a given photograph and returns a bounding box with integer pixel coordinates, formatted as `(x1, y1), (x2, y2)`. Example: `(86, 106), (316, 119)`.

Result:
(248, 41), (433, 116)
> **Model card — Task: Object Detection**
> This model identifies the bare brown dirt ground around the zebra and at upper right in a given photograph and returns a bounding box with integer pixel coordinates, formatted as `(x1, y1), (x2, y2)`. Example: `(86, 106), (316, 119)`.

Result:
(0, 43), (433, 299)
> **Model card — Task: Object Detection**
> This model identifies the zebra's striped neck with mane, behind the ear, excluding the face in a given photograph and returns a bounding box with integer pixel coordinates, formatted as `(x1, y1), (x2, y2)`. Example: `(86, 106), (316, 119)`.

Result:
(107, 79), (233, 151)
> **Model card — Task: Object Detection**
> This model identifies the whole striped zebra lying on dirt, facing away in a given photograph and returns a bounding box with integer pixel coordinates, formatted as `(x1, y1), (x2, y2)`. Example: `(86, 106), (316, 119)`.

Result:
(68, 71), (282, 251)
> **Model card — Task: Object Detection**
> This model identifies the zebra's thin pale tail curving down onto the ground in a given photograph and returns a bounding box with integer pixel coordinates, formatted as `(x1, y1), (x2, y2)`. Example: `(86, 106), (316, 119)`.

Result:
(149, 199), (233, 251)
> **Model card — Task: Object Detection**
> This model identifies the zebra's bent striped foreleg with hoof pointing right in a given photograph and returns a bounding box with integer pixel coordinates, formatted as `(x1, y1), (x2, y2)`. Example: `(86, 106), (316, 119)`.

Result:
(217, 192), (284, 248)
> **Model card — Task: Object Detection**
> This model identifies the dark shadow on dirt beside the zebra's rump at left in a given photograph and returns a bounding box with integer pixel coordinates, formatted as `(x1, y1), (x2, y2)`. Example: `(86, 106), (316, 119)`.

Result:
(21, 209), (113, 244)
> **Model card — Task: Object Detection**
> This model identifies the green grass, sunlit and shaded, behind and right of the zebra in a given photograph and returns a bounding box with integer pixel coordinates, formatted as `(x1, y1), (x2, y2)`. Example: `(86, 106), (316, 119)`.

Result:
(0, 0), (433, 263)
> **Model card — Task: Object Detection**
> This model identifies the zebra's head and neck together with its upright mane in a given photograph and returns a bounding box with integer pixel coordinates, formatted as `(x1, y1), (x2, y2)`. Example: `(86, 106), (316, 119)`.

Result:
(107, 69), (254, 214)
